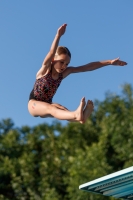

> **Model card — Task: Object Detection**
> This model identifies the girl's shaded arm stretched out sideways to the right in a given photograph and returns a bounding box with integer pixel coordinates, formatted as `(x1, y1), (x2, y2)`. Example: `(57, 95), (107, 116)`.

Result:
(64, 58), (127, 78)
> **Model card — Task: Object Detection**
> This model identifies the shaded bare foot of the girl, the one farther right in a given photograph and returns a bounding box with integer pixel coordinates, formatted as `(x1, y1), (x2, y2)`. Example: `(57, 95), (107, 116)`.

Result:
(83, 100), (94, 123)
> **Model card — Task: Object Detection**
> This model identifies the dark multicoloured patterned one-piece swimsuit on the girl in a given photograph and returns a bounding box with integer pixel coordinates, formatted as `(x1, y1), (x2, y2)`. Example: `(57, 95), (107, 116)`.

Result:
(29, 71), (63, 103)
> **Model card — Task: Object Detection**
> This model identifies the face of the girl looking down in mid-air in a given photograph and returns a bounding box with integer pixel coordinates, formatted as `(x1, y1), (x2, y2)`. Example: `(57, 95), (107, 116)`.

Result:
(52, 54), (70, 73)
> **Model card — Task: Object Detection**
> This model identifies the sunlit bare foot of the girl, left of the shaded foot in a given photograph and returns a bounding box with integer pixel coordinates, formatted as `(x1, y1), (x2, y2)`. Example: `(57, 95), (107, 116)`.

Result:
(75, 97), (85, 121)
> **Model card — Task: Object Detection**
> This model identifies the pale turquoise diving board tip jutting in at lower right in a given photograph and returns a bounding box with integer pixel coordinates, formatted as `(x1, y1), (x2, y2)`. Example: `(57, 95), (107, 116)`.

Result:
(79, 166), (133, 200)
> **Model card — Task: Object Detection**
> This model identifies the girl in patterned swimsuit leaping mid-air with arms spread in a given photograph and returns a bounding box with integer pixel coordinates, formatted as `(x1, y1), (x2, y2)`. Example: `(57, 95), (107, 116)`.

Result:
(28, 24), (127, 123)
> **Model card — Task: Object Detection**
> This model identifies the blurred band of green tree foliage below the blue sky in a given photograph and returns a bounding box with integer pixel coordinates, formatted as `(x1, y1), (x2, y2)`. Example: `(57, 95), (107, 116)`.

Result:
(0, 84), (133, 200)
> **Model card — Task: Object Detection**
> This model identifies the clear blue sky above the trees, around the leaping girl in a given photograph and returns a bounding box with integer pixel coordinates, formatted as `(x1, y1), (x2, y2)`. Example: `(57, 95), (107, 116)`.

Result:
(0, 0), (133, 127)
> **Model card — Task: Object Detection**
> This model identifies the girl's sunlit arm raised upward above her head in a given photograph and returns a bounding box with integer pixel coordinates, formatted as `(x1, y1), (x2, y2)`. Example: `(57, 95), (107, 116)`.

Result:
(36, 24), (67, 79)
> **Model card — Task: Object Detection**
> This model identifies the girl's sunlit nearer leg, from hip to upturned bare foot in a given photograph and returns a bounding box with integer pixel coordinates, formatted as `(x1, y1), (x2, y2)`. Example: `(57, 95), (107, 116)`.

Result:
(28, 98), (85, 121)
